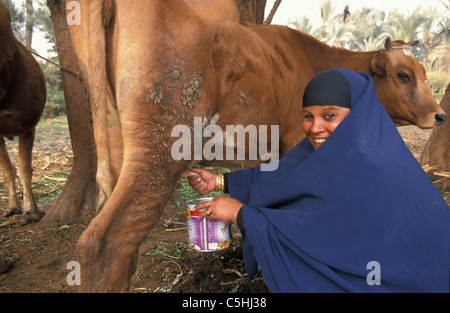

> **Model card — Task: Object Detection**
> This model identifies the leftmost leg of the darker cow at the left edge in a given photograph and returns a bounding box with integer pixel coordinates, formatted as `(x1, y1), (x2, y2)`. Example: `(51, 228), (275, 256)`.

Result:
(0, 138), (22, 217)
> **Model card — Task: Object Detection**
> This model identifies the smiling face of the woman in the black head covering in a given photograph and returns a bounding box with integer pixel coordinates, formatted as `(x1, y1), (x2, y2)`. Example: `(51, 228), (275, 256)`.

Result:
(302, 105), (350, 150)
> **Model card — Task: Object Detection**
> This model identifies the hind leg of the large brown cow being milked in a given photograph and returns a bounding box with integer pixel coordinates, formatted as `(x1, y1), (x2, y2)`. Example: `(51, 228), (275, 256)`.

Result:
(77, 111), (188, 292)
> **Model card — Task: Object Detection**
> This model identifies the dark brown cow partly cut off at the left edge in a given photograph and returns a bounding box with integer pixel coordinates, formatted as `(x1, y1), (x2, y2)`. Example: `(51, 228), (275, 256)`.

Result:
(0, 3), (46, 222)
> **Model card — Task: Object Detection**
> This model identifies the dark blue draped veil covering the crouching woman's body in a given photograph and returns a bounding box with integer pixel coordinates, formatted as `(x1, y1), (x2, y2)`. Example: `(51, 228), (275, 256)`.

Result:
(228, 69), (450, 292)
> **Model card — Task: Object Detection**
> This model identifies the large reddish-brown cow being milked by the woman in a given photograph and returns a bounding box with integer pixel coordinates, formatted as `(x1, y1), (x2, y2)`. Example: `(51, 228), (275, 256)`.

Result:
(68, 0), (445, 292)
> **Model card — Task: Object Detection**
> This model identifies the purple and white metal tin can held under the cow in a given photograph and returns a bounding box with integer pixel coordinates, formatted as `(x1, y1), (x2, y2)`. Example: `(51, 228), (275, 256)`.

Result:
(187, 198), (231, 252)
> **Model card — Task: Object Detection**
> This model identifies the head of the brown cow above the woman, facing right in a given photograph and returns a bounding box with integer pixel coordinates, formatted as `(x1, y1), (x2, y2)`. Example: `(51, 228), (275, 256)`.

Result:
(371, 37), (446, 128)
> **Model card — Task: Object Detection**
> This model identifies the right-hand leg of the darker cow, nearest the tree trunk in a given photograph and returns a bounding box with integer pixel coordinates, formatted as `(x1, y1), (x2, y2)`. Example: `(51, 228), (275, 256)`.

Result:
(19, 128), (44, 223)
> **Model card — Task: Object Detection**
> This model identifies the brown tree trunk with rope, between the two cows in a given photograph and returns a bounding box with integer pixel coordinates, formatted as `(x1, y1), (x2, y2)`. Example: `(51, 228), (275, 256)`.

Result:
(41, 0), (97, 224)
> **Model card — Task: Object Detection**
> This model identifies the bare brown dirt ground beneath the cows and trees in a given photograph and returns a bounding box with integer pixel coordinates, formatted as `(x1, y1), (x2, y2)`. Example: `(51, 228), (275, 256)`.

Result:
(0, 118), (450, 293)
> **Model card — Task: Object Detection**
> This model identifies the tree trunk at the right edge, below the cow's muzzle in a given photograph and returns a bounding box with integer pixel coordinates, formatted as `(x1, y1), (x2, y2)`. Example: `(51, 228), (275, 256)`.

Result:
(421, 84), (450, 172)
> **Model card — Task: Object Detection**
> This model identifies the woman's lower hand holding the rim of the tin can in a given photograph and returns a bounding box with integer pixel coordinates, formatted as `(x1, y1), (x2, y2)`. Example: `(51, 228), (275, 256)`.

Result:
(194, 196), (244, 224)
